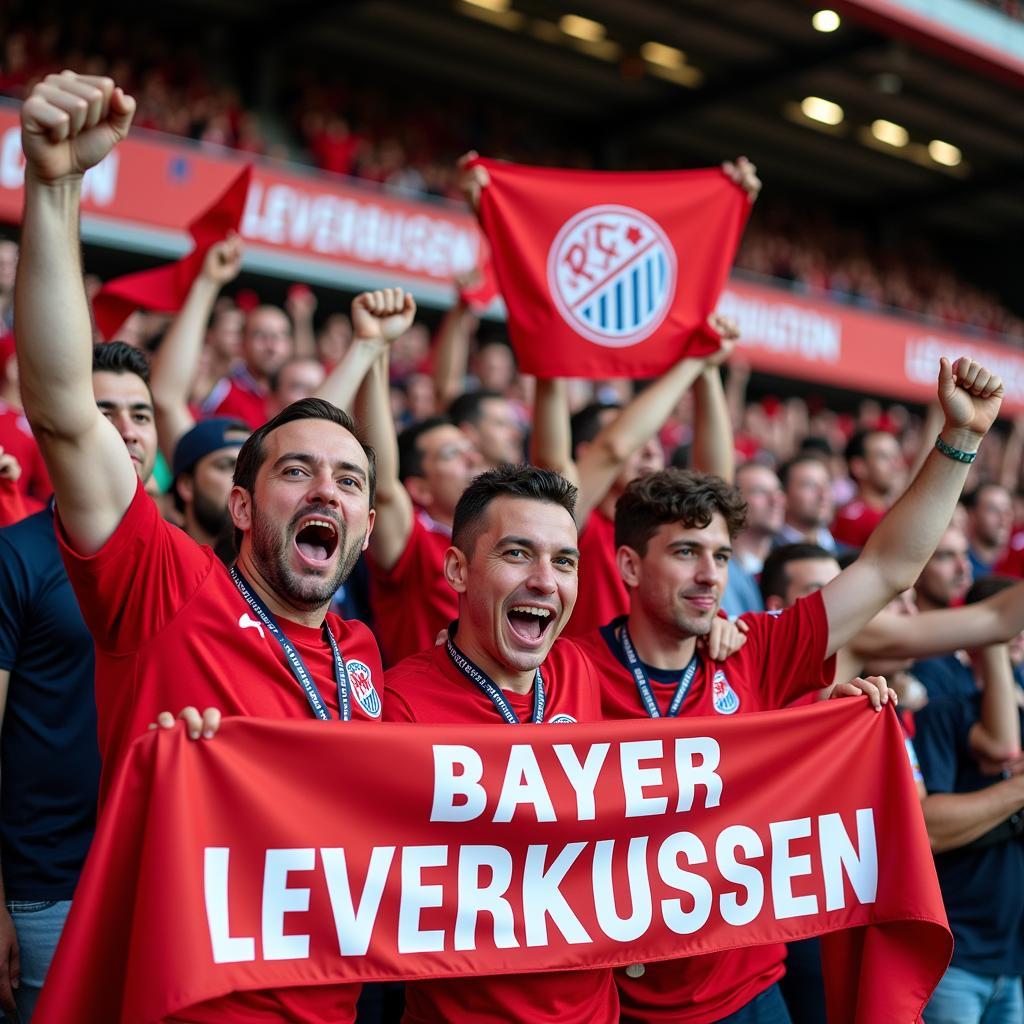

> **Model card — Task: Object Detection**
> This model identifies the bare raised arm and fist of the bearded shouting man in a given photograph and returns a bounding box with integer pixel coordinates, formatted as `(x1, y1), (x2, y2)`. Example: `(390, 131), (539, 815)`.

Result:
(14, 72), (137, 554)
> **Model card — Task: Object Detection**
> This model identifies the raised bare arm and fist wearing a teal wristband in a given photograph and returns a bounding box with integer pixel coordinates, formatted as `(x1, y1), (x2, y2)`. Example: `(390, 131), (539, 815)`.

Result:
(822, 358), (1002, 654)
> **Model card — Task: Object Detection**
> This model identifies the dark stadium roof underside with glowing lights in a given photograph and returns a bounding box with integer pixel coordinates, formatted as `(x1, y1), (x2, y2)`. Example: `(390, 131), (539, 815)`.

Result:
(232, 0), (1024, 246)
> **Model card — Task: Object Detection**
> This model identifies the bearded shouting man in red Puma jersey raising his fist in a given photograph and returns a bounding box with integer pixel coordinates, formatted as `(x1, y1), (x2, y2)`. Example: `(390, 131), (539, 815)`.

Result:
(15, 72), (382, 1024)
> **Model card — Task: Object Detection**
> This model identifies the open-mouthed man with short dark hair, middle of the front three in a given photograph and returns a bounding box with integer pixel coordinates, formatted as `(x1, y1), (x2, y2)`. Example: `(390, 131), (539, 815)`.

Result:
(384, 466), (618, 1024)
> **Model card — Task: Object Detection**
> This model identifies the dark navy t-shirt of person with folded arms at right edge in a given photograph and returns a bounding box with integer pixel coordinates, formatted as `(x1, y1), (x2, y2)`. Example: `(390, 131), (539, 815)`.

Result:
(913, 693), (1024, 975)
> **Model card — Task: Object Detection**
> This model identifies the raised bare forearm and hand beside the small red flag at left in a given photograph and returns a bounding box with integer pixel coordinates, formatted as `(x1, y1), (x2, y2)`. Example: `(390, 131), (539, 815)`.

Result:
(150, 231), (242, 462)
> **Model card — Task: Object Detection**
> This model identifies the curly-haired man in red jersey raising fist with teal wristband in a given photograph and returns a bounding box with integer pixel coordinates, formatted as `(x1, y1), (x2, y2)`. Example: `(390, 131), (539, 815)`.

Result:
(583, 348), (1002, 1024)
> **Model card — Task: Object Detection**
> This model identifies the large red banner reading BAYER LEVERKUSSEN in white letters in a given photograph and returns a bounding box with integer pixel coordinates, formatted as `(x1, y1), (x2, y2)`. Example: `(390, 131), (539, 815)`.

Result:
(34, 700), (951, 1024)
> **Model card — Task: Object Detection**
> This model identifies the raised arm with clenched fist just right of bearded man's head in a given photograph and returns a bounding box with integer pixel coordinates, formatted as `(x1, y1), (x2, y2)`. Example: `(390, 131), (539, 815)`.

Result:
(351, 288), (416, 571)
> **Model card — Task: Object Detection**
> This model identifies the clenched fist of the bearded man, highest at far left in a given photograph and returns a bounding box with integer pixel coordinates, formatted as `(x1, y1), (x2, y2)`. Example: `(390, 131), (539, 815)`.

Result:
(22, 71), (135, 182)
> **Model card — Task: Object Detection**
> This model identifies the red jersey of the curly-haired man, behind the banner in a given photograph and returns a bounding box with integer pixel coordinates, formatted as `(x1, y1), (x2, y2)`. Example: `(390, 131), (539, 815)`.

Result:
(580, 593), (836, 1024)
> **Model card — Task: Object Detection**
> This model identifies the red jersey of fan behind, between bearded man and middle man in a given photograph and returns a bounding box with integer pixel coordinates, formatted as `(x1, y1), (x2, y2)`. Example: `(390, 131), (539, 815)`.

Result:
(367, 510), (459, 666)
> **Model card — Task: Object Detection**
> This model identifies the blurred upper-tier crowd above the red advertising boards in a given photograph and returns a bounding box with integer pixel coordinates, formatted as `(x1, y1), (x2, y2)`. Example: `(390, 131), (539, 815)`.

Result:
(0, 9), (1024, 341)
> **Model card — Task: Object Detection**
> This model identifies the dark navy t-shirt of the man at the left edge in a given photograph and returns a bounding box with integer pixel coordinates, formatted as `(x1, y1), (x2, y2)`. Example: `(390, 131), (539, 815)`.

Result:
(0, 509), (99, 900)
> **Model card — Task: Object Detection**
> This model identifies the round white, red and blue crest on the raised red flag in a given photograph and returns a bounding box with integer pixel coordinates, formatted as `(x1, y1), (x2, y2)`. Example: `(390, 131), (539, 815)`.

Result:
(548, 205), (676, 348)
